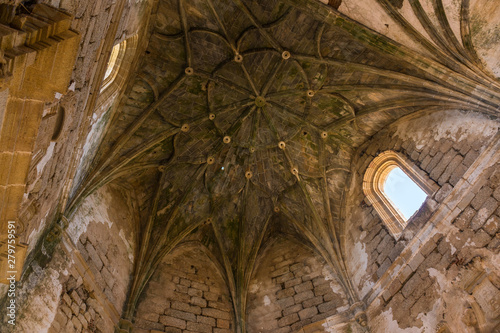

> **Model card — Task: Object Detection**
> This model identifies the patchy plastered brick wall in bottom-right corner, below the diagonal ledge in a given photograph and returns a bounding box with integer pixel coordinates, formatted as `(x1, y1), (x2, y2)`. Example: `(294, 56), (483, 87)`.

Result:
(373, 163), (500, 332)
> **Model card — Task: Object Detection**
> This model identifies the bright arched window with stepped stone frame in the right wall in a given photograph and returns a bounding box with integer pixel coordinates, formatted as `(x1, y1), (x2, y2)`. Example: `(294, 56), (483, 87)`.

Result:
(363, 151), (438, 239)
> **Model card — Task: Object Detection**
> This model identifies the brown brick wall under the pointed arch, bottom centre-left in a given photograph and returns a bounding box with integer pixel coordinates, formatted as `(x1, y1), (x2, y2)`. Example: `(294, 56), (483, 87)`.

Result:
(134, 246), (235, 333)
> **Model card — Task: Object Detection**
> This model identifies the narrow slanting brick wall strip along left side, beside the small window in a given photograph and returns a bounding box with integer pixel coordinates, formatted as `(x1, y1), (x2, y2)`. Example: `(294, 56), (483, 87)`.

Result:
(16, 0), (144, 262)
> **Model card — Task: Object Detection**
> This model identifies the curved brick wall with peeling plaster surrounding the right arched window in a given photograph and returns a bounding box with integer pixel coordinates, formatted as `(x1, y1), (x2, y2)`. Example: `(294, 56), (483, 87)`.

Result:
(348, 113), (495, 295)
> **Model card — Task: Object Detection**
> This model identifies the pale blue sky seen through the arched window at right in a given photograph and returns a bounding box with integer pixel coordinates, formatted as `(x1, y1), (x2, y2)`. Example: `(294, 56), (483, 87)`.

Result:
(384, 168), (427, 220)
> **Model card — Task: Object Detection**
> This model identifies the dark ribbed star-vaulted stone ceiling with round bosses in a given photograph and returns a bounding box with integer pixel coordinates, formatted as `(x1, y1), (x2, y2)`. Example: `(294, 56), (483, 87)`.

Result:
(67, 0), (500, 326)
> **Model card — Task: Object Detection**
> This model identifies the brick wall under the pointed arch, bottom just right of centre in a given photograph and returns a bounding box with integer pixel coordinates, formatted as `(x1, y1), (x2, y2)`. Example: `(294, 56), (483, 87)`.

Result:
(247, 239), (348, 333)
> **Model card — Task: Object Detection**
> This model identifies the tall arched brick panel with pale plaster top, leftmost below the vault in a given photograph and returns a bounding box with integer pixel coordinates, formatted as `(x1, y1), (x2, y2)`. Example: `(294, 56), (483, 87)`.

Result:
(51, 186), (137, 332)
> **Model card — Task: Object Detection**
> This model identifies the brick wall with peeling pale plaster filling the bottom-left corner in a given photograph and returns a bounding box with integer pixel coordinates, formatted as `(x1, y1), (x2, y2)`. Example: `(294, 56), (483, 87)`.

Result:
(0, 186), (137, 333)
